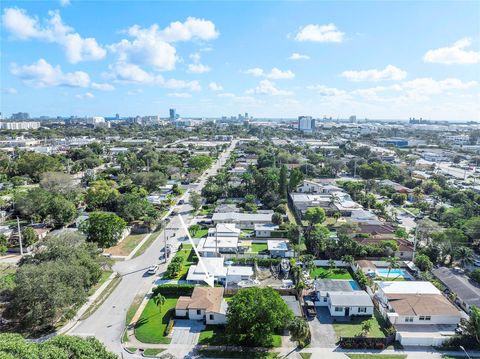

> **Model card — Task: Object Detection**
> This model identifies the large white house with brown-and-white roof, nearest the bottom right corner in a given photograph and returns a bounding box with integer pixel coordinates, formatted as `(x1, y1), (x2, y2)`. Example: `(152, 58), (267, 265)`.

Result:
(375, 281), (461, 346)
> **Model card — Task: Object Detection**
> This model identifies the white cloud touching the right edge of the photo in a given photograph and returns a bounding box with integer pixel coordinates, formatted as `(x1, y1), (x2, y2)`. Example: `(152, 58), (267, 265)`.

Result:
(423, 38), (480, 65)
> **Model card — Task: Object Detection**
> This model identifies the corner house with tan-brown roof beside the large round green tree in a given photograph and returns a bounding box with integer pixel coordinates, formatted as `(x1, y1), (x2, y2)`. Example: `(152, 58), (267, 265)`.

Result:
(175, 287), (228, 325)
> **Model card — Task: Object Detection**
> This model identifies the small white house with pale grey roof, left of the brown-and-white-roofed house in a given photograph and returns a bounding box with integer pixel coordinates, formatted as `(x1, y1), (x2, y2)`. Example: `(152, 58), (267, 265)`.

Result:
(314, 279), (374, 317)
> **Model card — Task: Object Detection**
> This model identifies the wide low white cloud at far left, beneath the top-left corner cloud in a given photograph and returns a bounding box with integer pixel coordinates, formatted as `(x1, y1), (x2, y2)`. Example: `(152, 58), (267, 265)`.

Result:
(10, 59), (90, 87)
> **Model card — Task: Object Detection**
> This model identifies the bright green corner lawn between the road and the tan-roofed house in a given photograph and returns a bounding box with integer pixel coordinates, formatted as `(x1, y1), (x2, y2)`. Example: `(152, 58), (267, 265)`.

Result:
(135, 297), (178, 344)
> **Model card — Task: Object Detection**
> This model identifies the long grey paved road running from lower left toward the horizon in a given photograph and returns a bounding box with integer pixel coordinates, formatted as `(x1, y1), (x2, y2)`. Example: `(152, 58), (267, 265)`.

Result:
(69, 141), (237, 358)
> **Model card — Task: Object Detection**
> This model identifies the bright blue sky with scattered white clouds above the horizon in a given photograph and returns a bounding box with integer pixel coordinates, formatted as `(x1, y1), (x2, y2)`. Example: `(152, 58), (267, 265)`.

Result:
(0, 0), (480, 121)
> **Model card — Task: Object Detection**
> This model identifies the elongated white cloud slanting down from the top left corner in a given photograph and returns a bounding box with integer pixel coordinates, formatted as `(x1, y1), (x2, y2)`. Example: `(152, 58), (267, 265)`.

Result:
(2, 8), (107, 64)
